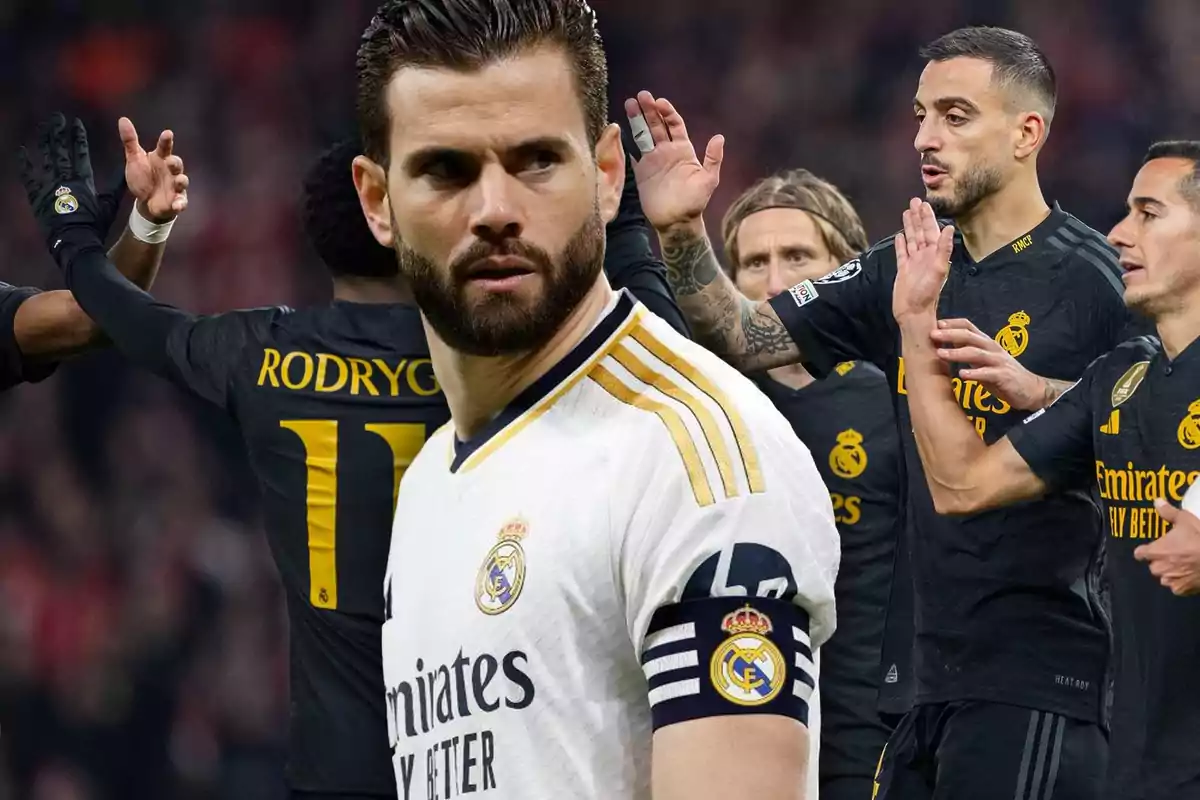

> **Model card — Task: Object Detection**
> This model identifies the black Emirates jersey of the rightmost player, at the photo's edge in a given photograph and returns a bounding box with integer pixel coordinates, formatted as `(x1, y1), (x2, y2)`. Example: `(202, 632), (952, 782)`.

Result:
(1008, 337), (1200, 800)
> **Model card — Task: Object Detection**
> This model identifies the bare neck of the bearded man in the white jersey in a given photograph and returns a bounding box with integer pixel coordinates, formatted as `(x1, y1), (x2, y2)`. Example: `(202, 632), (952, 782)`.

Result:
(425, 275), (613, 441)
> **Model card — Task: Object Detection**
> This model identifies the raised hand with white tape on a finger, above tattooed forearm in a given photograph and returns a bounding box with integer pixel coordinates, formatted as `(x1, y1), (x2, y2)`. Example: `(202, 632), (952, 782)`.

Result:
(625, 91), (725, 233)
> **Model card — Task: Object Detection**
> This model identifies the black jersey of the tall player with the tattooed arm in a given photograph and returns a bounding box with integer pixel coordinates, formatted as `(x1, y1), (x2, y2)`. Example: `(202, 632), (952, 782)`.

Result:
(772, 201), (1145, 721)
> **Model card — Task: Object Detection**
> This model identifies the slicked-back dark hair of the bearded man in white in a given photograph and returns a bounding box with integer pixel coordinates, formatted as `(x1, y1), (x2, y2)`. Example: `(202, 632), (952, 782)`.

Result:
(356, 0), (608, 164)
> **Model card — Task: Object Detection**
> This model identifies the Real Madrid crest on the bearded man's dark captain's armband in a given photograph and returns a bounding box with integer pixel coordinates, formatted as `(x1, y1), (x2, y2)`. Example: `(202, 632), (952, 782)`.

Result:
(709, 604), (787, 705)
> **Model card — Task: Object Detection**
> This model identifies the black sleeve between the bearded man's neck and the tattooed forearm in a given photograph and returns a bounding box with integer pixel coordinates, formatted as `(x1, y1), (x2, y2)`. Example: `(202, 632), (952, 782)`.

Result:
(604, 126), (691, 338)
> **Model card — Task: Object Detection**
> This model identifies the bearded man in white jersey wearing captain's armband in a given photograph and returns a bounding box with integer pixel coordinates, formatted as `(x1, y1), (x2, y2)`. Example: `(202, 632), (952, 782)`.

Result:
(354, 0), (838, 800)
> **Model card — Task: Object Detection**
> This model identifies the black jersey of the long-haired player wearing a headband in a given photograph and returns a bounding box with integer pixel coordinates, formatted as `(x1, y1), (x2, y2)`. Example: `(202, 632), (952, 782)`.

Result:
(757, 361), (912, 781)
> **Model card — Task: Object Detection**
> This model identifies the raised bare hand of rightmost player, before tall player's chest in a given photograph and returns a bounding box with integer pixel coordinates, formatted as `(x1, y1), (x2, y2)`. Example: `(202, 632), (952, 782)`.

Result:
(892, 198), (954, 324)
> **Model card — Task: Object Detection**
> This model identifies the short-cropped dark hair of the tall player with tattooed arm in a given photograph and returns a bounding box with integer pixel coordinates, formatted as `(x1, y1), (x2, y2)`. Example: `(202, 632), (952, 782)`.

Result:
(920, 25), (1058, 125)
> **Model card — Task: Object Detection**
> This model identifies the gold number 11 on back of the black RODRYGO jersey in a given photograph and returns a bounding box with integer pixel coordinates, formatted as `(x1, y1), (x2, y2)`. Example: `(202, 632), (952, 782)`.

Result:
(280, 420), (425, 610)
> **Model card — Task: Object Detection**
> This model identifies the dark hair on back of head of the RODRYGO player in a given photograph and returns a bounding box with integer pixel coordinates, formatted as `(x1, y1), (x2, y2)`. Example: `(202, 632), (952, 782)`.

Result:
(301, 138), (400, 278)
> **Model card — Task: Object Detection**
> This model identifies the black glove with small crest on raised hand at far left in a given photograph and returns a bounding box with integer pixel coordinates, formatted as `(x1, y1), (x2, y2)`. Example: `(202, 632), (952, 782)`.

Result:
(18, 114), (126, 270)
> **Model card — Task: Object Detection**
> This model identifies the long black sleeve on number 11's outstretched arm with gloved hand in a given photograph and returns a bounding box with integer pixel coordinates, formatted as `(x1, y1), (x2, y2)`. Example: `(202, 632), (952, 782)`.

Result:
(66, 249), (278, 408)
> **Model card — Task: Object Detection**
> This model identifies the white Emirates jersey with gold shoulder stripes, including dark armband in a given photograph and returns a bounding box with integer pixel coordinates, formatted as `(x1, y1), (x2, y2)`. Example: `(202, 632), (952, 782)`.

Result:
(383, 294), (839, 800)
